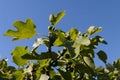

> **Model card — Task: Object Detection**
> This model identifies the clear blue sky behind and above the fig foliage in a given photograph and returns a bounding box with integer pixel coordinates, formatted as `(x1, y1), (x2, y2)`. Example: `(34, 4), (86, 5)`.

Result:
(0, 0), (120, 65)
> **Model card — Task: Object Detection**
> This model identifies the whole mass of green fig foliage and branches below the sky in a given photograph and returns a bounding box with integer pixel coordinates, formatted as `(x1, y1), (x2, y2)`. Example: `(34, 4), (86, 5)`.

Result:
(0, 11), (120, 80)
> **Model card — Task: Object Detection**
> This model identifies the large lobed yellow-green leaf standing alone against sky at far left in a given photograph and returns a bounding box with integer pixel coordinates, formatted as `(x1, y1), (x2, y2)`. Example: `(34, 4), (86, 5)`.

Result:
(4, 19), (36, 41)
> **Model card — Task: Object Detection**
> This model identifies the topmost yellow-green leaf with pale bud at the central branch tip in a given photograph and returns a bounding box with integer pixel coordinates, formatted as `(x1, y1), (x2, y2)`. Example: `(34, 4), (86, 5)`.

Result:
(49, 11), (65, 26)
